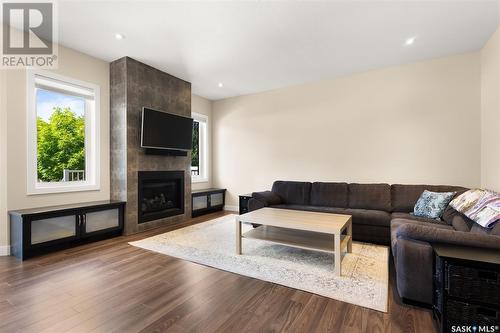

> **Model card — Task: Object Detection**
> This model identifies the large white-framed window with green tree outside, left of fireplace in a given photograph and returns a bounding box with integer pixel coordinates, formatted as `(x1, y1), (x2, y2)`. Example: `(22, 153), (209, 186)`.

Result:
(27, 71), (99, 194)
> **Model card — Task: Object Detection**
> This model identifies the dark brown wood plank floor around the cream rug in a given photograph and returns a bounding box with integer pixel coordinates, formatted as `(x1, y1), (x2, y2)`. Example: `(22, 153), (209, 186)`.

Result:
(0, 213), (435, 333)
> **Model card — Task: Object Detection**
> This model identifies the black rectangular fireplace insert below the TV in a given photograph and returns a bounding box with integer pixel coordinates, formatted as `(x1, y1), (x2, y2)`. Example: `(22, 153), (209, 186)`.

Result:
(137, 171), (184, 223)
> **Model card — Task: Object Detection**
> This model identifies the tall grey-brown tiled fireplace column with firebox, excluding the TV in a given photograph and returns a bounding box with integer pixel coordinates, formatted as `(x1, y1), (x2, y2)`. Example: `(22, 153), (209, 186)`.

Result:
(110, 57), (191, 235)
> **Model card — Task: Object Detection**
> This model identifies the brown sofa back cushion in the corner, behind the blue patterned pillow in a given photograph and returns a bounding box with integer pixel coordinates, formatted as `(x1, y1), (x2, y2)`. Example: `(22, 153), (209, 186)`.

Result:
(391, 184), (467, 211)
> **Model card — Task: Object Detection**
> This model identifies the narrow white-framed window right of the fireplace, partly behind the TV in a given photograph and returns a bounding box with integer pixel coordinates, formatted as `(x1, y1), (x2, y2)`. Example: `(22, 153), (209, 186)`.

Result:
(191, 113), (208, 183)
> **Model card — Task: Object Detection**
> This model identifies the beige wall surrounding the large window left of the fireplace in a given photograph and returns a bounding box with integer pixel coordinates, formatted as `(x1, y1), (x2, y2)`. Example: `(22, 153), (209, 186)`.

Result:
(0, 47), (109, 250)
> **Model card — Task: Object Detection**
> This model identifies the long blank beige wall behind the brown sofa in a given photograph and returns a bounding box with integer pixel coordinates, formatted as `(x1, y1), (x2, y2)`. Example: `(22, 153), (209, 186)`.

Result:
(213, 53), (481, 206)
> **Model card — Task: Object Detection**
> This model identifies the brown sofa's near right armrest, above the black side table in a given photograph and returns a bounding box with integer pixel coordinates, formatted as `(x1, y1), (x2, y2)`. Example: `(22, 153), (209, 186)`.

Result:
(396, 224), (500, 250)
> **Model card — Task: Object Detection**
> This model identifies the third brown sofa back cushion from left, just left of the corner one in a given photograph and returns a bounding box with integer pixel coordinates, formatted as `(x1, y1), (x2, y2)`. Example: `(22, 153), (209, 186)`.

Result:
(349, 183), (391, 212)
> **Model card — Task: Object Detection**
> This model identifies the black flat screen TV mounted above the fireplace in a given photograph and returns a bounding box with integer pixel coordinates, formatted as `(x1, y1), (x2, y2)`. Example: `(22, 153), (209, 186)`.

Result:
(141, 108), (193, 151)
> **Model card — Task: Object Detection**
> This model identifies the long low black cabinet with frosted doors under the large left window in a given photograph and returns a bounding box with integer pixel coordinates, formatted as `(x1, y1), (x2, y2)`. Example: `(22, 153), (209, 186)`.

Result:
(9, 200), (125, 260)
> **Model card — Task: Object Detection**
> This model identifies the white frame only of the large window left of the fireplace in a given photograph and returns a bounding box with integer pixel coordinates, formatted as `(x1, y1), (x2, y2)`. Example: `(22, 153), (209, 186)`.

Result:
(26, 69), (101, 195)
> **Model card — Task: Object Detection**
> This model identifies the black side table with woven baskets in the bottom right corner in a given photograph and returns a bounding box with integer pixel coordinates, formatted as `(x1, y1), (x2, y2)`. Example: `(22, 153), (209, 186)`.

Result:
(432, 244), (500, 332)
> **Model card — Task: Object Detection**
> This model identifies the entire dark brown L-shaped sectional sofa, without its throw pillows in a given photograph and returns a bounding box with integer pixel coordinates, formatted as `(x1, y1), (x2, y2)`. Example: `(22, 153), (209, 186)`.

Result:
(248, 181), (500, 304)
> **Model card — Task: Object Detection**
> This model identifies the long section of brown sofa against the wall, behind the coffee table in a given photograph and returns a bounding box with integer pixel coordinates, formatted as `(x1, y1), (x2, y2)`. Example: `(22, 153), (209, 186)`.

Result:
(252, 181), (466, 245)
